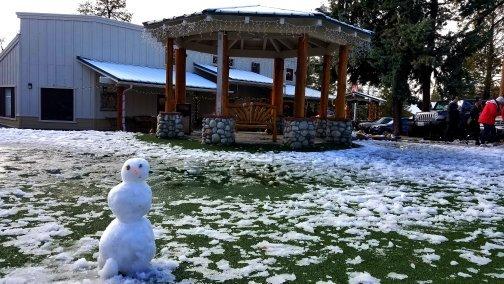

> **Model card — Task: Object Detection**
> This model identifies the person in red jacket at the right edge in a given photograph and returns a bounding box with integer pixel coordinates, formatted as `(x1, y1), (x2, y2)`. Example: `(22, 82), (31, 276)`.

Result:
(478, 97), (504, 144)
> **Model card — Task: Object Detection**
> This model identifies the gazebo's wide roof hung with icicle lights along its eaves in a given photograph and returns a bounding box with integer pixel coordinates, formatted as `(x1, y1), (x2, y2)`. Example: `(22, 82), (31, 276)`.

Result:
(144, 5), (373, 58)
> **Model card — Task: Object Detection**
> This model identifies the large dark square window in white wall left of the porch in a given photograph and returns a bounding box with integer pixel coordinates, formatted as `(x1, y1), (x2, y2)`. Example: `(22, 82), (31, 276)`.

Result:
(40, 88), (74, 121)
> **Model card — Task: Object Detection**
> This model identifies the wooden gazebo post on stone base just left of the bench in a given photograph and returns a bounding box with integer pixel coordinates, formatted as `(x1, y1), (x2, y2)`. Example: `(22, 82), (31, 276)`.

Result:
(215, 32), (229, 115)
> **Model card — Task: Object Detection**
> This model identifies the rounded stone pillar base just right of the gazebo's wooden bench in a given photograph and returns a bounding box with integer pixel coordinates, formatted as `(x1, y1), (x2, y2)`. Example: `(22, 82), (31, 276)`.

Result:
(283, 117), (316, 150)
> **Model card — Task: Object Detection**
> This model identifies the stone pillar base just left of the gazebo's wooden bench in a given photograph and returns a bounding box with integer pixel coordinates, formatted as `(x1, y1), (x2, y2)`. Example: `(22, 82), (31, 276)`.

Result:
(201, 116), (235, 145)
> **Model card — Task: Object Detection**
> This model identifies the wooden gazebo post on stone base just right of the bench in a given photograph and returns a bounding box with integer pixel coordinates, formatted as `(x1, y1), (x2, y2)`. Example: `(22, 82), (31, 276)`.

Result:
(294, 34), (308, 118)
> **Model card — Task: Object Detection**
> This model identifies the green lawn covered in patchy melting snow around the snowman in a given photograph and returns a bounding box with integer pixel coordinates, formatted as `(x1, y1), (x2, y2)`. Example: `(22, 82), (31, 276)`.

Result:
(0, 129), (504, 283)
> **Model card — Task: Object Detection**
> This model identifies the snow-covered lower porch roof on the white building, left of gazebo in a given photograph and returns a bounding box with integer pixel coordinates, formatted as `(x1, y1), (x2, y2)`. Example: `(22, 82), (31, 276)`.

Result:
(77, 57), (217, 91)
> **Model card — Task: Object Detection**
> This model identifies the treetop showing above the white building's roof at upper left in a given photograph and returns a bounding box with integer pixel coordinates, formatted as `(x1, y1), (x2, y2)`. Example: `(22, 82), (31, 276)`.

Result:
(77, 0), (133, 22)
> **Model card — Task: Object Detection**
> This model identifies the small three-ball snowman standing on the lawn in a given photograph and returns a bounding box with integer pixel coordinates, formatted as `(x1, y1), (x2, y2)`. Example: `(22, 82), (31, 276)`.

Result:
(98, 158), (156, 279)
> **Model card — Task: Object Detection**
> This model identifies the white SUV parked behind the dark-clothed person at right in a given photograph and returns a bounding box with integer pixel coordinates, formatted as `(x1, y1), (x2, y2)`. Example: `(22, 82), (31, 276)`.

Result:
(412, 99), (475, 138)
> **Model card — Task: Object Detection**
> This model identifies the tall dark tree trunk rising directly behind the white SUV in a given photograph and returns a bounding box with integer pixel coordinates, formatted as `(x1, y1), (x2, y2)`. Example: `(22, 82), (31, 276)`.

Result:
(420, 0), (439, 111)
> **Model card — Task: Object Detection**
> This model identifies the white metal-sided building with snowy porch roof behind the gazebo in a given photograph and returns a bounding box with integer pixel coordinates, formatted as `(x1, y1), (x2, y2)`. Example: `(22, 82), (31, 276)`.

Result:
(0, 13), (319, 129)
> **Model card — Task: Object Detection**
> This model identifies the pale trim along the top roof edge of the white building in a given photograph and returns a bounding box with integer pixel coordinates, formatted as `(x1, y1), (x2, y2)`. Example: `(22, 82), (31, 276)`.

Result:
(16, 12), (143, 31)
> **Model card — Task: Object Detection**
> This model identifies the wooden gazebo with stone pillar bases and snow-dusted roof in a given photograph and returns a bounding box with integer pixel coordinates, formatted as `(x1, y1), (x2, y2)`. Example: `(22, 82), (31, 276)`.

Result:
(144, 6), (372, 148)
